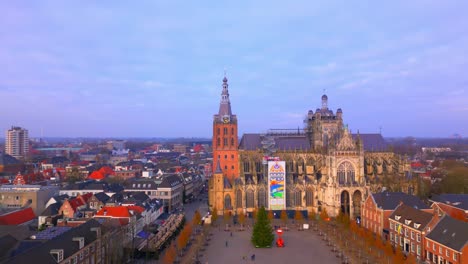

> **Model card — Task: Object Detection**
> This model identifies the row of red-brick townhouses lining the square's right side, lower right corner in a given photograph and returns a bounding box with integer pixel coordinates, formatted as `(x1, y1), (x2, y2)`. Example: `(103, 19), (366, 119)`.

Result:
(361, 192), (468, 263)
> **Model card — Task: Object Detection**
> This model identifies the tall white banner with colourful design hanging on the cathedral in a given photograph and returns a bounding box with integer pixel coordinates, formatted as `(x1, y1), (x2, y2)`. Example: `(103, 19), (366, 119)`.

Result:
(268, 161), (286, 210)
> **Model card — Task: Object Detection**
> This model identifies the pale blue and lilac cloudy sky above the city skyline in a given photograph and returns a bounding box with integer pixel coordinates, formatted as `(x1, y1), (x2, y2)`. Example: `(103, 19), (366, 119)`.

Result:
(0, 0), (468, 137)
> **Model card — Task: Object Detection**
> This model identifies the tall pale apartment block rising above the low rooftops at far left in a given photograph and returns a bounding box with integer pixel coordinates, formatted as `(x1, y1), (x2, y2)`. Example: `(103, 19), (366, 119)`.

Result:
(5, 126), (29, 159)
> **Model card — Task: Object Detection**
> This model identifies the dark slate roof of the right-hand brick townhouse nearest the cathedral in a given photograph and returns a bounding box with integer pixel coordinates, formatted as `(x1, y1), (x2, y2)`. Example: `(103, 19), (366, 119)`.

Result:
(371, 192), (430, 210)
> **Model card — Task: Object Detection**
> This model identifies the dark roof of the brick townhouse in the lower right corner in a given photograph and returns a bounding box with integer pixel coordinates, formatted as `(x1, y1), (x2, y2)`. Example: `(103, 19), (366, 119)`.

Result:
(426, 215), (468, 252)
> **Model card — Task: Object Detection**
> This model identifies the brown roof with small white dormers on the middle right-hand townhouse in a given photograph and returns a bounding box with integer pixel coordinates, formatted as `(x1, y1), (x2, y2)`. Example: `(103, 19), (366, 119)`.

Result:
(389, 204), (433, 231)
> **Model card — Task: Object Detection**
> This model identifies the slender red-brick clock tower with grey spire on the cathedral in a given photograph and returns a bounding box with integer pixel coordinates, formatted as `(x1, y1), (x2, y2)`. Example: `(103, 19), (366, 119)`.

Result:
(212, 76), (239, 180)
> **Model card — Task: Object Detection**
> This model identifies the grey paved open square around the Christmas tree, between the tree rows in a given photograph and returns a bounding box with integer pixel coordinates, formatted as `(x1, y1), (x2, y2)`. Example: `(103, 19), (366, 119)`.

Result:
(200, 225), (340, 264)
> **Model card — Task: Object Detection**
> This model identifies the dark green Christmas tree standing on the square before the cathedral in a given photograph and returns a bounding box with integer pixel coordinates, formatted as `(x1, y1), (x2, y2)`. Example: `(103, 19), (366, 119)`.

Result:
(251, 207), (275, 248)
